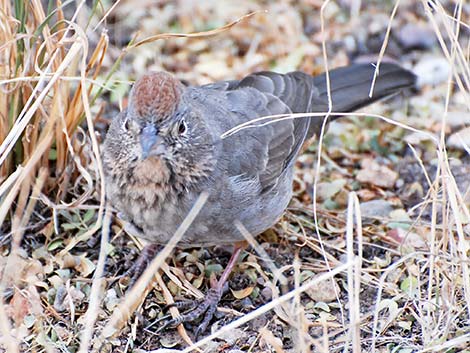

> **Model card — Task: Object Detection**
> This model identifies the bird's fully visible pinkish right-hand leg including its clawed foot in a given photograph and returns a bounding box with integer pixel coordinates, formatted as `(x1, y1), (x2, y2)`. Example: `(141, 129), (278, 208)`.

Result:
(157, 242), (247, 339)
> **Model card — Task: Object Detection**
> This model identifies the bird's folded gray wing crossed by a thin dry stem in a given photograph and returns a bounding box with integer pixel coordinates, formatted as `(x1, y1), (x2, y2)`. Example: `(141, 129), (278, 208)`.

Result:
(203, 72), (322, 191)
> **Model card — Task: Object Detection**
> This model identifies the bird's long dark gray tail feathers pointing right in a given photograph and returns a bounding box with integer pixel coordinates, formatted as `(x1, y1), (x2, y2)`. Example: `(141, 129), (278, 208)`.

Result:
(314, 63), (416, 112)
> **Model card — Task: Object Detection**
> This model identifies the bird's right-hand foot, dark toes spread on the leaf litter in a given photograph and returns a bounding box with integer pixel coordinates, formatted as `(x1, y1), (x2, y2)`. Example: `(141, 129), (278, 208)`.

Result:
(151, 285), (223, 340)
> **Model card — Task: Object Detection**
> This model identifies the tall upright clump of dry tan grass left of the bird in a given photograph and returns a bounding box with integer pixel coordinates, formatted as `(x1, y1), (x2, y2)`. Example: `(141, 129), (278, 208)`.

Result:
(0, 1), (108, 239)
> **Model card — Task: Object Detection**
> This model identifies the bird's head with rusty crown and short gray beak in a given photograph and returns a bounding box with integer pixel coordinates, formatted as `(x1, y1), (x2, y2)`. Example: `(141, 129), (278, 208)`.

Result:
(104, 72), (214, 188)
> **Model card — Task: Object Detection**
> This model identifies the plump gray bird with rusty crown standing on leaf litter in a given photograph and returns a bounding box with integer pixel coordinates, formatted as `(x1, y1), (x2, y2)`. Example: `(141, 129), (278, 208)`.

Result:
(102, 63), (416, 336)
